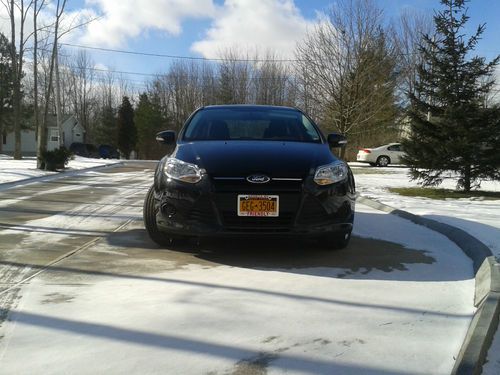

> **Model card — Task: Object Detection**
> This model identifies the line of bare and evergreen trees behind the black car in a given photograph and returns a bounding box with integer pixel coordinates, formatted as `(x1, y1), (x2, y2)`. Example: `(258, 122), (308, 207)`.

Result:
(0, 0), (500, 187)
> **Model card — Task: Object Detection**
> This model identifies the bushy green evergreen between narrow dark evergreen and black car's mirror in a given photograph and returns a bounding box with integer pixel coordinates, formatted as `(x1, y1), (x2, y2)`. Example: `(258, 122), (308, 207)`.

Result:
(134, 93), (166, 159)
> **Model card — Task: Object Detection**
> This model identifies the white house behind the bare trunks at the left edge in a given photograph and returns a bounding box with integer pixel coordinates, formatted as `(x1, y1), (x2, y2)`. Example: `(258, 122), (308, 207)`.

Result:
(1, 115), (85, 156)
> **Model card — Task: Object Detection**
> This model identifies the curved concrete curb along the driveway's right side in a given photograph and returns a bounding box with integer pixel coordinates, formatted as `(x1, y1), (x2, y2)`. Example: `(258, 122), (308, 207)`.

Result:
(357, 196), (500, 375)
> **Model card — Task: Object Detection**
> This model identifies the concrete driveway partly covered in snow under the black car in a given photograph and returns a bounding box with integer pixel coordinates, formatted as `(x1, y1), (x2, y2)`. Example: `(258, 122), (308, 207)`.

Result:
(0, 162), (474, 374)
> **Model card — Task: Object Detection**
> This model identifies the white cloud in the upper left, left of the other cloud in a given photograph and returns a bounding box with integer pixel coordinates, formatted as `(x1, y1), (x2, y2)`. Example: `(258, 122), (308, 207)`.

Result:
(80, 0), (215, 47)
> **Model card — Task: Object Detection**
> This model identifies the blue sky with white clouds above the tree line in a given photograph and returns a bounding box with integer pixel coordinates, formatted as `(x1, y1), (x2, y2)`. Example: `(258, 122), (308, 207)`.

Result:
(59, 0), (500, 86)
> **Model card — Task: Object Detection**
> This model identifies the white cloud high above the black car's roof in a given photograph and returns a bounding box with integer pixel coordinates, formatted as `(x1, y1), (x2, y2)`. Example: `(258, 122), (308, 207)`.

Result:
(191, 0), (312, 58)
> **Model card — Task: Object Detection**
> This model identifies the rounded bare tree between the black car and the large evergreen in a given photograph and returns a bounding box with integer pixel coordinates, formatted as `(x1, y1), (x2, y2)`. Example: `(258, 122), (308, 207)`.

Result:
(296, 0), (395, 157)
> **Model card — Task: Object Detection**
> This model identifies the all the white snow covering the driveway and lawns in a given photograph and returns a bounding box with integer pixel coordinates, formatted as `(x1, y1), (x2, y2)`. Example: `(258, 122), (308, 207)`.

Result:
(0, 158), (494, 374)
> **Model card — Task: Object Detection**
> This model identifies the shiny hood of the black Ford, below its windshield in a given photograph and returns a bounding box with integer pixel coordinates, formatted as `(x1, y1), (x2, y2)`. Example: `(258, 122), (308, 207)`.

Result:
(171, 141), (337, 178)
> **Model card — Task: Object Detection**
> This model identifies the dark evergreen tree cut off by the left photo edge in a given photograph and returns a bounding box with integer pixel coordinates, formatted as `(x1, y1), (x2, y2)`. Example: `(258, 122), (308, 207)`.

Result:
(0, 33), (14, 151)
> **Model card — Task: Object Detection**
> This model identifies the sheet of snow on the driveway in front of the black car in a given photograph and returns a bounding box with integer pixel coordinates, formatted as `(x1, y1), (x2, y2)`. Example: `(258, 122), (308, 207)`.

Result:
(0, 205), (474, 375)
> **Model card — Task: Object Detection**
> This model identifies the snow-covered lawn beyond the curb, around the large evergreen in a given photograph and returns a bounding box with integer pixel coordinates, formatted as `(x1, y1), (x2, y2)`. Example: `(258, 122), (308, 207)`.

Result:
(350, 163), (500, 375)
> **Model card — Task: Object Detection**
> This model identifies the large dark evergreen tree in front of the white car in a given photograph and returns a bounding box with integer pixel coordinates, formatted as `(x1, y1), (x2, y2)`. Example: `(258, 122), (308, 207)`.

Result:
(403, 0), (500, 191)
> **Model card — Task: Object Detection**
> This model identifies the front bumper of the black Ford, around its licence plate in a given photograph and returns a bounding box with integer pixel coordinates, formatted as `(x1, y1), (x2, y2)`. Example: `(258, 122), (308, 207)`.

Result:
(155, 173), (356, 237)
